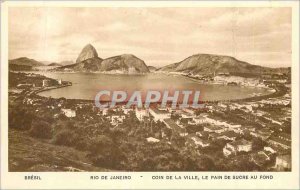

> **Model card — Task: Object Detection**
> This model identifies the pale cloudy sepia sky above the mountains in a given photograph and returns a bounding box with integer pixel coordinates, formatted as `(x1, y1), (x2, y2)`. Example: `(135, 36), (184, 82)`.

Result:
(8, 7), (292, 67)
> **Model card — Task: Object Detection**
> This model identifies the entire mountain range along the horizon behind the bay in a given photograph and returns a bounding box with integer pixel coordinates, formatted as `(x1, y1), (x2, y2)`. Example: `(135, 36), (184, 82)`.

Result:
(9, 48), (291, 75)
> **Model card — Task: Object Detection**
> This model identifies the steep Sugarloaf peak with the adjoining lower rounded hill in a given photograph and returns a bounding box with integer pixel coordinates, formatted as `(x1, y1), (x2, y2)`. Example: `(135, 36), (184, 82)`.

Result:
(54, 44), (149, 73)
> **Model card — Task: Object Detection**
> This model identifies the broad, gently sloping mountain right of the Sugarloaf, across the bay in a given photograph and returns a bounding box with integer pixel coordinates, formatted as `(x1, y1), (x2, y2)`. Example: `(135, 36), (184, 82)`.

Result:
(159, 54), (287, 74)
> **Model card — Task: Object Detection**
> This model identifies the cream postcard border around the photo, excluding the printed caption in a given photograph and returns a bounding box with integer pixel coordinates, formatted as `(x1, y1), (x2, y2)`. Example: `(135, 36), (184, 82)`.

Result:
(1, 1), (299, 189)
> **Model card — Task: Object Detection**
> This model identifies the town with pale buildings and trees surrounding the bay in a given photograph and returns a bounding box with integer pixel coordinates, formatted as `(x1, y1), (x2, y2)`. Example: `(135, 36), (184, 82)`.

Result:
(9, 71), (291, 171)
